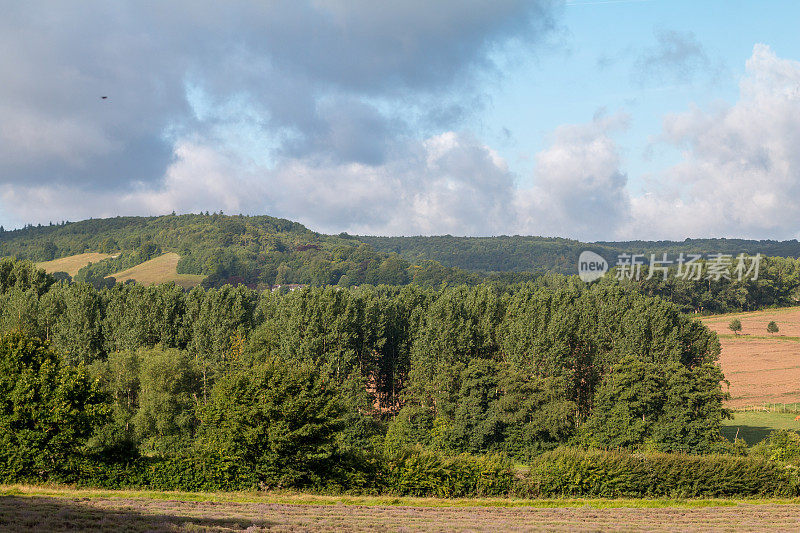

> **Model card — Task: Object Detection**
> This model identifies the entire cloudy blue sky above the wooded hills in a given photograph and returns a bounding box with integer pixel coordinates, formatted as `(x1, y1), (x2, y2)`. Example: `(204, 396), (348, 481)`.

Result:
(0, 0), (800, 241)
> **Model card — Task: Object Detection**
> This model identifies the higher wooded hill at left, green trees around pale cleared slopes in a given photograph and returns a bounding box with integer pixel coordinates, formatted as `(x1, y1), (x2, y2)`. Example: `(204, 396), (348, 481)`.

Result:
(0, 213), (477, 288)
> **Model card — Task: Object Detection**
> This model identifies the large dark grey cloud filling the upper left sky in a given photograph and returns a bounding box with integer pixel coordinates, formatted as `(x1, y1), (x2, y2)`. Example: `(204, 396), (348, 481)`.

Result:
(0, 0), (552, 195)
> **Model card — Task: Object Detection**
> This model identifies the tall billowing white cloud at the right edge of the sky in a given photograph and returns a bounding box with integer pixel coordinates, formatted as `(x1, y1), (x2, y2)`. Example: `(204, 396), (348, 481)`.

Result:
(624, 44), (800, 238)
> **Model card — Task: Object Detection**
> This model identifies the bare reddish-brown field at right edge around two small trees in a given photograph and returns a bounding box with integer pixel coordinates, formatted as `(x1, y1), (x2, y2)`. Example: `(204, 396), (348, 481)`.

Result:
(703, 307), (800, 408)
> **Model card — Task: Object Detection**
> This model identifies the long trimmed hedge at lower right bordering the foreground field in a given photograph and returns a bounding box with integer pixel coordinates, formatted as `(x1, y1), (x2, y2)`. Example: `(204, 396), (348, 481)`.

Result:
(517, 448), (798, 498)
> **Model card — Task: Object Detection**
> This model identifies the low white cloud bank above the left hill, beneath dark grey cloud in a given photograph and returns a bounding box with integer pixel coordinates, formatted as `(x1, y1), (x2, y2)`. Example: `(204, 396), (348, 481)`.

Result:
(0, 132), (514, 235)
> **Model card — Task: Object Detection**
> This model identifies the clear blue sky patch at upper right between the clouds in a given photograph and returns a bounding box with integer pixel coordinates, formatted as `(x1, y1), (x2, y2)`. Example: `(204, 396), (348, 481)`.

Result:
(484, 0), (800, 189)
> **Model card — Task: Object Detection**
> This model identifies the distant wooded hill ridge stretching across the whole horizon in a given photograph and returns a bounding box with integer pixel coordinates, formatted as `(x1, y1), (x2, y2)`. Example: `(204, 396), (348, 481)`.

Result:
(0, 213), (800, 313)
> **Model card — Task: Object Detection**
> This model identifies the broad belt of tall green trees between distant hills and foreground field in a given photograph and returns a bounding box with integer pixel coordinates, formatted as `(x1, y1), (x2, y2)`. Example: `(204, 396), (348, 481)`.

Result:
(0, 256), (793, 496)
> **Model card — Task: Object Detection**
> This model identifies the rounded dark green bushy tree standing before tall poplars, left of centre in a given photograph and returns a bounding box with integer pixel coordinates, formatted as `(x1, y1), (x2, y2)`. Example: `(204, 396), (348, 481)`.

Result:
(198, 360), (344, 487)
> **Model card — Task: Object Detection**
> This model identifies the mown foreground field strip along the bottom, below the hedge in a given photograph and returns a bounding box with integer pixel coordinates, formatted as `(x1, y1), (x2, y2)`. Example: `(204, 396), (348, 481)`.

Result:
(0, 487), (800, 532)
